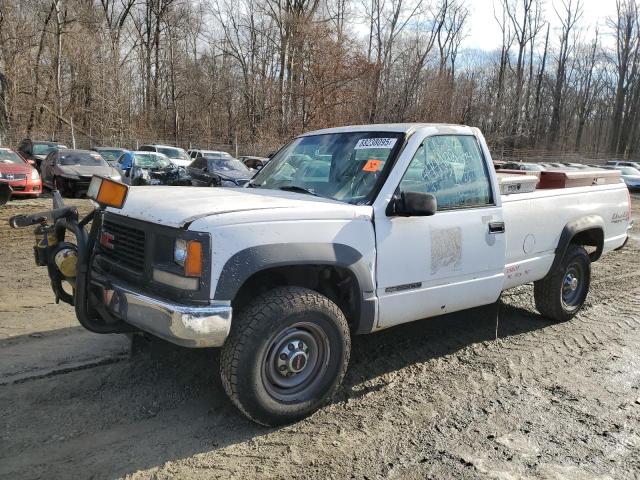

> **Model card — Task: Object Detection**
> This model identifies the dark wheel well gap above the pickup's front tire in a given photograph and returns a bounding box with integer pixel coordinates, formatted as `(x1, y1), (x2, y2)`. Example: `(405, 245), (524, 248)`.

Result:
(231, 265), (361, 330)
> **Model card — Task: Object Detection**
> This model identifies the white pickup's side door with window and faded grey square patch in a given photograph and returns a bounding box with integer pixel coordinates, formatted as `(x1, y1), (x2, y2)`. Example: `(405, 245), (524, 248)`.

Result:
(375, 135), (505, 327)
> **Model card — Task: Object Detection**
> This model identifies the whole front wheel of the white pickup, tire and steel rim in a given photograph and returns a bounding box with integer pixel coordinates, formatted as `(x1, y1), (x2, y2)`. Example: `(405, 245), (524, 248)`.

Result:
(220, 287), (351, 426)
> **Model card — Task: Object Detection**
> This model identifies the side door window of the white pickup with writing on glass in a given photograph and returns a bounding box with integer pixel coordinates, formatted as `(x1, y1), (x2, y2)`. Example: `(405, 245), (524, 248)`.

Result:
(400, 135), (493, 210)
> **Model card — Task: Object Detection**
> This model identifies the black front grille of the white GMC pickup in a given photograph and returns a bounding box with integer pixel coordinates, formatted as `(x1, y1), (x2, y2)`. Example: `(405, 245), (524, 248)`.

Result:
(101, 218), (145, 273)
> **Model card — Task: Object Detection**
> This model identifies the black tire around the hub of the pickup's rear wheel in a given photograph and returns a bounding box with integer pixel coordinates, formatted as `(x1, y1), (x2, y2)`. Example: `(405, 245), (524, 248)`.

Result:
(533, 243), (591, 322)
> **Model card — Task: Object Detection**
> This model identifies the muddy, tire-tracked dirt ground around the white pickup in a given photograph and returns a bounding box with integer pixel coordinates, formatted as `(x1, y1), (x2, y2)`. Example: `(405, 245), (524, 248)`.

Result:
(0, 196), (640, 480)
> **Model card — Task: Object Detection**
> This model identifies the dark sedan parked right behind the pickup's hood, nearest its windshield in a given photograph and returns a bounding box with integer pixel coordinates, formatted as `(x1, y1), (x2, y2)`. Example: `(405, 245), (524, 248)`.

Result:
(187, 156), (253, 187)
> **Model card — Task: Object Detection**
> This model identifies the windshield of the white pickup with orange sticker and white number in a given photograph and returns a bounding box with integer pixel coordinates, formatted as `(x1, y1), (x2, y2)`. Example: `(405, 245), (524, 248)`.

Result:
(252, 132), (403, 203)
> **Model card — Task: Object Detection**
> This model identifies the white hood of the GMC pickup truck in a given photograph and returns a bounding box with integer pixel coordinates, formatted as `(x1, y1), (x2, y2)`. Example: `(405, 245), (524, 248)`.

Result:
(108, 186), (372, 228)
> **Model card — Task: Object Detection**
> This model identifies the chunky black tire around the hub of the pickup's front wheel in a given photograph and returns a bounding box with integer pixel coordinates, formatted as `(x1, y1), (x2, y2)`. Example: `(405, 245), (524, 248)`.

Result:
(220, 287), (351, 426)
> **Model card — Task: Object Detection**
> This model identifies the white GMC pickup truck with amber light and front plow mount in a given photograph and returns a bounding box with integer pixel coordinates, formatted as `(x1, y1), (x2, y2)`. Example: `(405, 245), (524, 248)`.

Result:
(10, 124), (631, 425)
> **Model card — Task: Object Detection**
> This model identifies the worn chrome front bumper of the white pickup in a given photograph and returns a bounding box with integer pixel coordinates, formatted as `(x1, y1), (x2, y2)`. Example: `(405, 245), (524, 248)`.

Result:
(105, 285), (231, 348)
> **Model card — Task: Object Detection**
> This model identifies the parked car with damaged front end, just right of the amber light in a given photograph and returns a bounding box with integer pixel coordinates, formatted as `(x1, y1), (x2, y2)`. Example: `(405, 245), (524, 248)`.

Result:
(118, 151), (191, 185)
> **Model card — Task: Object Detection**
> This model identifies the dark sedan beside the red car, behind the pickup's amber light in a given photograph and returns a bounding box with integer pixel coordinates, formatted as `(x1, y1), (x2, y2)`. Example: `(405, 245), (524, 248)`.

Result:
(41, 149), (122, 196)
